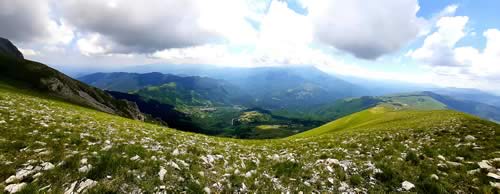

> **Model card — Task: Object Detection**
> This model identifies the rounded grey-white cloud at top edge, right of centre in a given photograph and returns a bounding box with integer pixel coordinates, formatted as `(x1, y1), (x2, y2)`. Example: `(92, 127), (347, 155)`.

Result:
(302, 0), (425, 59)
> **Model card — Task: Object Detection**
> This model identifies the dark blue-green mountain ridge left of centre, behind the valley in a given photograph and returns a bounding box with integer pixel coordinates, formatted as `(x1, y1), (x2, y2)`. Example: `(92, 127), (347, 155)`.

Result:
(78, 72), (251, 106)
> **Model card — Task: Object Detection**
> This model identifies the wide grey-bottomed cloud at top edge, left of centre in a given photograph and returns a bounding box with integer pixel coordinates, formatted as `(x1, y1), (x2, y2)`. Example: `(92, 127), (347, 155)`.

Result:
(61, 0), (253, 53)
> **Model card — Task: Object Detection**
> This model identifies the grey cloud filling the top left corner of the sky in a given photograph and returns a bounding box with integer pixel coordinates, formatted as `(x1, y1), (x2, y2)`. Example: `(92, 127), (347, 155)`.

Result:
(0, 0), (74, 44)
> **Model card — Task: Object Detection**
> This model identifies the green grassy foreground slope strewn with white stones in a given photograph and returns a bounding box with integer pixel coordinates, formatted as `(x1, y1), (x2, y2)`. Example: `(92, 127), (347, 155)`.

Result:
(0, 86), (500, 193)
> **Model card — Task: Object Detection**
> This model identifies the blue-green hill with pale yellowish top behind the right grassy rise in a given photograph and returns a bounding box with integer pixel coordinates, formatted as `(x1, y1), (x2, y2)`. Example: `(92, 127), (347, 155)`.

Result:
(273, 92), (500, 122)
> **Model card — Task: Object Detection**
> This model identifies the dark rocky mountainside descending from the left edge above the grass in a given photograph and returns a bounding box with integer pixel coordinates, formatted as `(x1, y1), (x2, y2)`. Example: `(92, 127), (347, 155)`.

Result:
(0, 36), (144, 120)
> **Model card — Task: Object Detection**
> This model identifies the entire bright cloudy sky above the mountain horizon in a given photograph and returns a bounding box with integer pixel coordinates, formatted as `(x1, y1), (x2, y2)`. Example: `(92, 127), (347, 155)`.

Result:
(0, 0), (500, 94)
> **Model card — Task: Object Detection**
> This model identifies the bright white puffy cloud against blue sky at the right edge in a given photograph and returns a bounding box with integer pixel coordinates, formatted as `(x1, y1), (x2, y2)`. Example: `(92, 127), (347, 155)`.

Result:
(407, 16), (500, 91)
